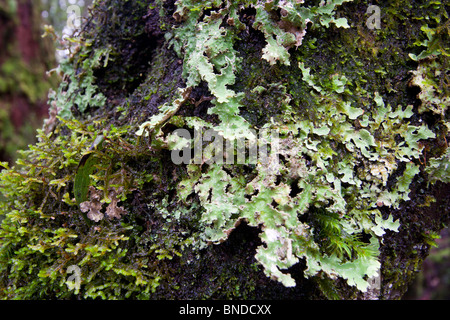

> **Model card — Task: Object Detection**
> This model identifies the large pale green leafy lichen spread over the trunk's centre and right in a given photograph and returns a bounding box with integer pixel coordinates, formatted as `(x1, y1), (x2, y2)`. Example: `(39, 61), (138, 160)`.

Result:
(134, 1), (442, 291)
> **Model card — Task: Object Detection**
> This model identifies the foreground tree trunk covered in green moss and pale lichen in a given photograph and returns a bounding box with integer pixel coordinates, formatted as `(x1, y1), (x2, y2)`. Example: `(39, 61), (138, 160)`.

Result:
(0, 0), (450, 299)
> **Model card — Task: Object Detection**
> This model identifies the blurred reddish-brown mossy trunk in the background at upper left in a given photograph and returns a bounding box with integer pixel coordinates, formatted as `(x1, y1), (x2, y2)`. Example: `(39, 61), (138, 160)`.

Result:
(0, 0), (56, 161)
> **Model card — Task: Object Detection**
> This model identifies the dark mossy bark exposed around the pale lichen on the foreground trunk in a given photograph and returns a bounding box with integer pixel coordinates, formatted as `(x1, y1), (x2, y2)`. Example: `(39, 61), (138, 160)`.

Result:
(0, 0), (450, 299)
